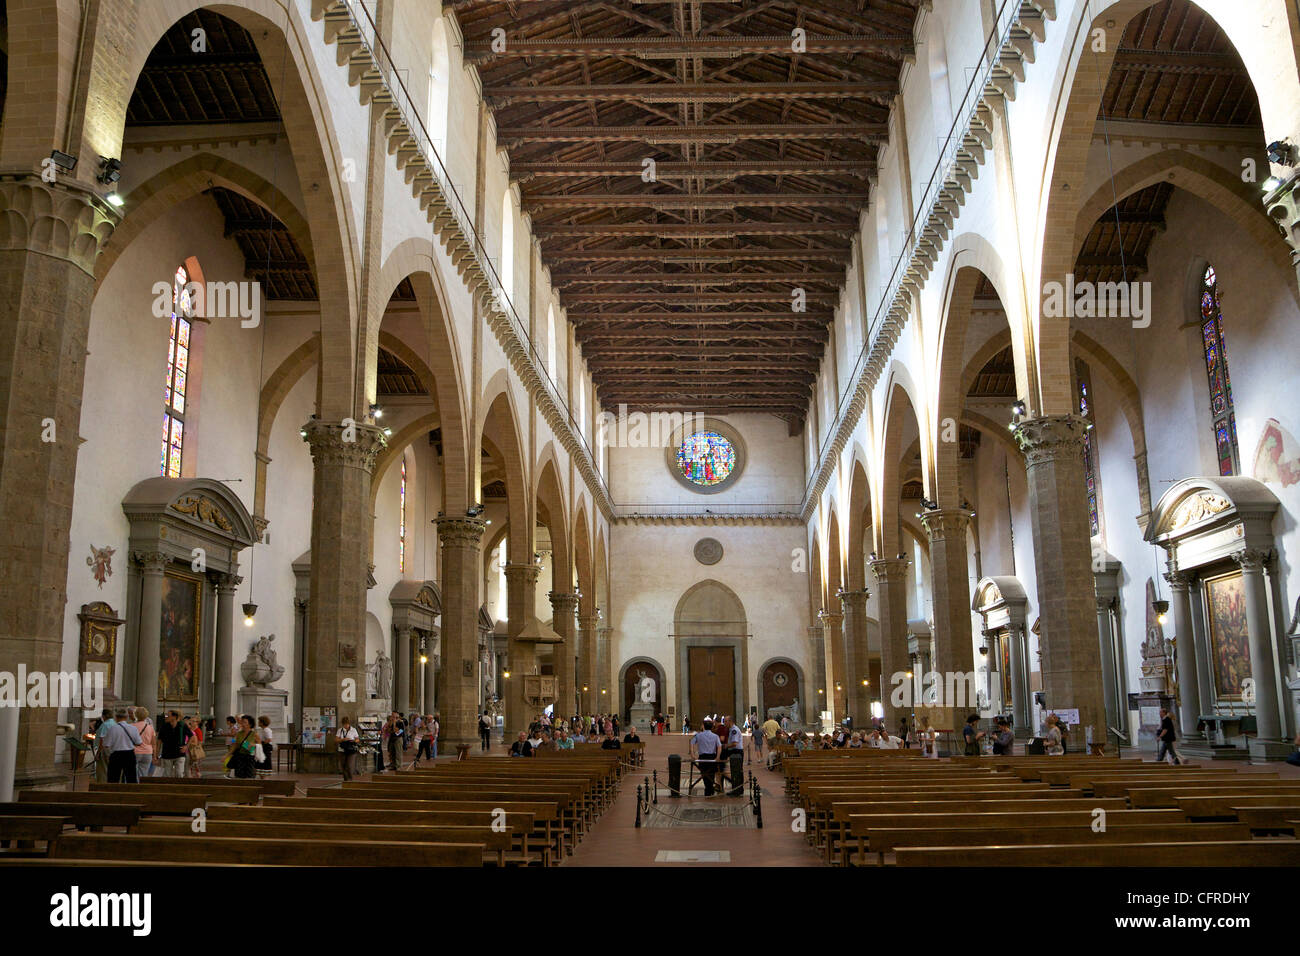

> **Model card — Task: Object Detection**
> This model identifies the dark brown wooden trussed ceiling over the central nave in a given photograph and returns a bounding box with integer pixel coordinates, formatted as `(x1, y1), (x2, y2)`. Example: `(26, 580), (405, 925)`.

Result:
(447, 0), (918, 428)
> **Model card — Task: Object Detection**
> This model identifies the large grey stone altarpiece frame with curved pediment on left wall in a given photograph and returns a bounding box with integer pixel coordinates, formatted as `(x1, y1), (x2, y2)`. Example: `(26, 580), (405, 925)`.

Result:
(120, 477), (259, 717)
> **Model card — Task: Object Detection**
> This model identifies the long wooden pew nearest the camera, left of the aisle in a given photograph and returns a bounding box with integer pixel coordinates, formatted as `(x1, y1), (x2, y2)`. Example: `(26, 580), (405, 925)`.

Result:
(52, 834), (484, 866)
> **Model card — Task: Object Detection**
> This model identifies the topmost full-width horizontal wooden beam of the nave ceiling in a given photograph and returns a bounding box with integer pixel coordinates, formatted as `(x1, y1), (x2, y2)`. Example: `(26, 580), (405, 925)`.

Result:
(464, 30), (917, 64)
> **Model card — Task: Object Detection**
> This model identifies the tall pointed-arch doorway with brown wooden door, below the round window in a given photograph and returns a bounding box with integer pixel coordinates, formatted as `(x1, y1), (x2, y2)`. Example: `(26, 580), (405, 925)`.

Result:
(673, 580), (750, 726)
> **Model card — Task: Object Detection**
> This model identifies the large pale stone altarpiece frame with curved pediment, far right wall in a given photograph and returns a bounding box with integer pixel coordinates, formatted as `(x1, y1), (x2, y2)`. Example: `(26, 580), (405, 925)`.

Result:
(1147, 477), (1295, 760)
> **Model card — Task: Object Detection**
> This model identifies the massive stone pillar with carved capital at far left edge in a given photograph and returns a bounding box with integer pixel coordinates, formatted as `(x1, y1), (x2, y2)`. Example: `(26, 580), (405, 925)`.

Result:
(0, 178), (118, 788)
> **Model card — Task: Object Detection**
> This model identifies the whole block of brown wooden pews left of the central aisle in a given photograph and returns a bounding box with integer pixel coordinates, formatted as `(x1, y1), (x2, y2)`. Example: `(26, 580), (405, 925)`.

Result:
(0, 750), (625, 866)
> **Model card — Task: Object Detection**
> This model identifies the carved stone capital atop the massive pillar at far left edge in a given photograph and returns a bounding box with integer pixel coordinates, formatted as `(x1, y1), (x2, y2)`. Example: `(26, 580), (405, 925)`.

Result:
(0, 173), (122, 276)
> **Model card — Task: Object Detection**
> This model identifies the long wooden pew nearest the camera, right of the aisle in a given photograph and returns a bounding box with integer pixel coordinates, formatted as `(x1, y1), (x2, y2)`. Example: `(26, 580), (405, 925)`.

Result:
(894, 840), (1300, 868)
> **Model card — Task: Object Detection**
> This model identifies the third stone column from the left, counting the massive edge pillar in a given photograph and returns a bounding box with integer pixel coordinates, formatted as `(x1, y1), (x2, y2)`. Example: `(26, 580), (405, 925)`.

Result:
(434, 518), (486, 752)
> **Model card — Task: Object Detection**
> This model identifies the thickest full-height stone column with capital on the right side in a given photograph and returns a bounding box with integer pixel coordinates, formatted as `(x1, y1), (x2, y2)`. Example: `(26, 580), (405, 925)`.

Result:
(1015, 415), (1106, 750)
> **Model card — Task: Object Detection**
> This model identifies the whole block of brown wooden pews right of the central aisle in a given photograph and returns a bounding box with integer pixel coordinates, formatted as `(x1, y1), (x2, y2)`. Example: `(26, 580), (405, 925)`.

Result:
(783, 749), (1300, 866)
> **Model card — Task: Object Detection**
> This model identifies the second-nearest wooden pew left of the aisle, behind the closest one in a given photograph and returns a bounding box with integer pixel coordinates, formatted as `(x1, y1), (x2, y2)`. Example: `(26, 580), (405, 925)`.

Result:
(137, 819), (519, 866)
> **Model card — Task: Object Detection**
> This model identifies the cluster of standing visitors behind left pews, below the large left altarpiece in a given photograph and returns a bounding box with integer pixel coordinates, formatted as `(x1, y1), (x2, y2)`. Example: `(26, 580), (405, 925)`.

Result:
(85, 708), (204, 783)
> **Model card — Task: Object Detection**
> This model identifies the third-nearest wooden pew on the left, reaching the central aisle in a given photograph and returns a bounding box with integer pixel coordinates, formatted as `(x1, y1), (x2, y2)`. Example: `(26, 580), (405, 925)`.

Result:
(208, 799), (543, 866)
